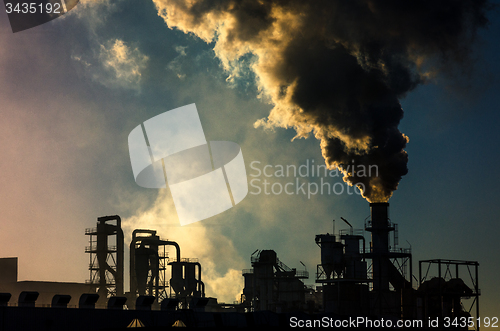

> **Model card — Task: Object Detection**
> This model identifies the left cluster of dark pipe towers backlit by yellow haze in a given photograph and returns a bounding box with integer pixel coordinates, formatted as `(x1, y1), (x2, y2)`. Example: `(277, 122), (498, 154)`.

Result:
(85, 215), (205, 308)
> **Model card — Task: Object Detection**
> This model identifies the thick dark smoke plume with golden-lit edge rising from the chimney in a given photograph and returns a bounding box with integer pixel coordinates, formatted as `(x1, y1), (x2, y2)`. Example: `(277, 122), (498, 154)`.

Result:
(153, 0), (491, 202)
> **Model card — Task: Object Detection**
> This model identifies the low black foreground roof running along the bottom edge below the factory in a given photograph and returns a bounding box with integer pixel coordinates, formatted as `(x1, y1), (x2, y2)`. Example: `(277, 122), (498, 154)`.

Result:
(0, 307), (437, 331)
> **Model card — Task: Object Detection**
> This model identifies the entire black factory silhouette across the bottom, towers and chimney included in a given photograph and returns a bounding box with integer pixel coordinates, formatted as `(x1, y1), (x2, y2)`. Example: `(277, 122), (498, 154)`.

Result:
(0, 203), (480, 331)
